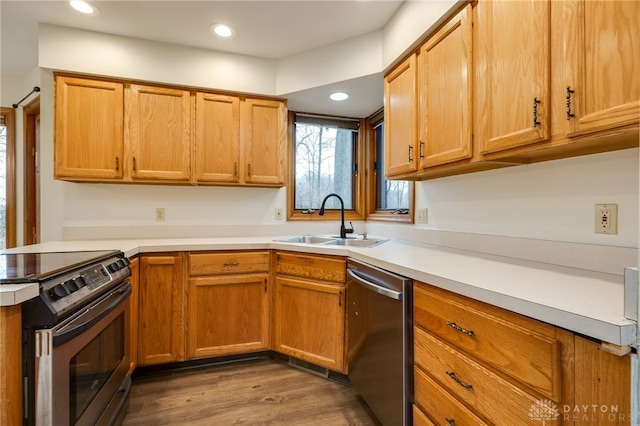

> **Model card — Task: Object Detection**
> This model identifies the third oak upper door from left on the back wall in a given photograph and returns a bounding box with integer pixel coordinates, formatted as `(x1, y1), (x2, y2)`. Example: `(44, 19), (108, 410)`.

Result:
(194, 93), (240, 183)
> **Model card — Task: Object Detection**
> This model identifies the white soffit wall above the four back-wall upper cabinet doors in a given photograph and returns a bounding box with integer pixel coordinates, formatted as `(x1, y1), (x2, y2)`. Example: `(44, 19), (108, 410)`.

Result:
(38, 24), (276, 95)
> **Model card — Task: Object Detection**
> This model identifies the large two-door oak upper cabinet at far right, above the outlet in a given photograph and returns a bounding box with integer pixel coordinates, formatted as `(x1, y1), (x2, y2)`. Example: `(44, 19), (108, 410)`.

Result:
(473, 0), (640, 163)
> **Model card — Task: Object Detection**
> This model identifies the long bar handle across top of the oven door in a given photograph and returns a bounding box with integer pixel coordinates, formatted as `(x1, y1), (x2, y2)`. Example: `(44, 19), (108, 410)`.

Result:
(53, 282), (131, 347)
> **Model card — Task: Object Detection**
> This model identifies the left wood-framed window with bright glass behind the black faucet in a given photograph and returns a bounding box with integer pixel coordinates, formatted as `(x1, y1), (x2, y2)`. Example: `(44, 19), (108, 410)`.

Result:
(290, 114), (362, 220)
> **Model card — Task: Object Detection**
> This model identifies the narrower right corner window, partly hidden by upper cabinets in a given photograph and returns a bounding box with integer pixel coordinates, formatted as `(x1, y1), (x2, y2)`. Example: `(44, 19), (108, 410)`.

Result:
(367, 111), (413, 223)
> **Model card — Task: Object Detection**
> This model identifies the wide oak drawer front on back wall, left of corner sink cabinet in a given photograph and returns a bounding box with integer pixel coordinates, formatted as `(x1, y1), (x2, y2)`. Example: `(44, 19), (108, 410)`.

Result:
(189, 251), (269, 276)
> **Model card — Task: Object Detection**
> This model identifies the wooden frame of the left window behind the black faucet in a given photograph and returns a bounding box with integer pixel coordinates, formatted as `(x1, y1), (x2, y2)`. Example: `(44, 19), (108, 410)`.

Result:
(287, 111), (366, 221)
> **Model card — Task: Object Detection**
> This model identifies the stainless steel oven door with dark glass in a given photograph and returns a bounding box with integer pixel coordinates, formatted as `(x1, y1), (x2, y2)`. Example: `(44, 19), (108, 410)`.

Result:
(35, 282), (131, 426)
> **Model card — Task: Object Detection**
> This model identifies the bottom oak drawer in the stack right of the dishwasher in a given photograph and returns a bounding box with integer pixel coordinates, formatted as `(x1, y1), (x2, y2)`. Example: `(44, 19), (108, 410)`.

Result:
(414, 368), (486, 426)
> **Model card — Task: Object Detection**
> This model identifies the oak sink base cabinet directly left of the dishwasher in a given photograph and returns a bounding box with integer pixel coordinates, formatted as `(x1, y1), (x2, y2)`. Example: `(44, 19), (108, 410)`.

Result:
(273, 252), (347, 373)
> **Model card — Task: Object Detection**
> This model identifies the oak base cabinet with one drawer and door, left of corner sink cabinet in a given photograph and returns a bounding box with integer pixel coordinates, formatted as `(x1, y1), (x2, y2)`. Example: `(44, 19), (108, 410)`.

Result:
(187, 251), (271, 359)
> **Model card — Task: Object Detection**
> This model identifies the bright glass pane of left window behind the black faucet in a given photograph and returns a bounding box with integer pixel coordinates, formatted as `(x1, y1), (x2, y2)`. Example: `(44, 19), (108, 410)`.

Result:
(294, 122), (356, 210)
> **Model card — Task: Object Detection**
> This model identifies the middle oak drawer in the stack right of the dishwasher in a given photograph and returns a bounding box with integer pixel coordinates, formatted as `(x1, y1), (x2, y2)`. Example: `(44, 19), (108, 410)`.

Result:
(414, 328), (538, 426)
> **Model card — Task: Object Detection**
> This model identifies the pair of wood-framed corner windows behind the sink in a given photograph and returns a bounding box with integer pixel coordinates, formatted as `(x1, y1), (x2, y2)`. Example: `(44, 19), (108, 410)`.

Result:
(288, 111), (413, 223)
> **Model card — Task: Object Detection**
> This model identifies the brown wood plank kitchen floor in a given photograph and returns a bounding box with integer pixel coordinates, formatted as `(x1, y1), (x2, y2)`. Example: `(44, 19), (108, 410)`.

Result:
(123, 360), (380, 426)
